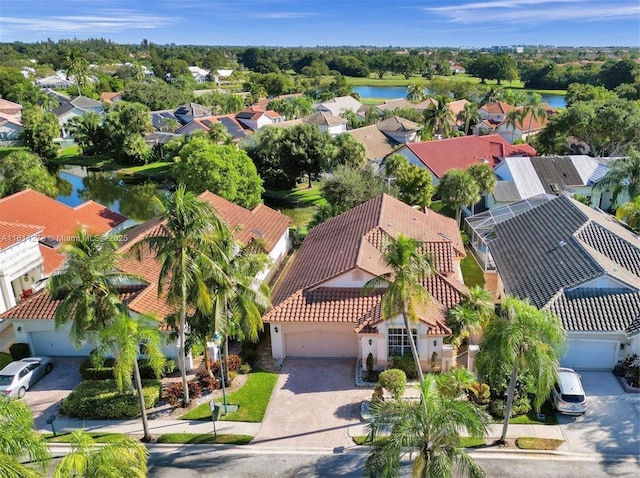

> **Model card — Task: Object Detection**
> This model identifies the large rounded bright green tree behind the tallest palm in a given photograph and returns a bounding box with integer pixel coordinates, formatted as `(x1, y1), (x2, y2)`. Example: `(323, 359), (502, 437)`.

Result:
(173, 134), (263, 209)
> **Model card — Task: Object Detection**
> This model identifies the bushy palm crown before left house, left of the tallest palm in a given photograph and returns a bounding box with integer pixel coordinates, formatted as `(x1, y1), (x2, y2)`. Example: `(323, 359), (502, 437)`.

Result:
(47, 229), (136, 348)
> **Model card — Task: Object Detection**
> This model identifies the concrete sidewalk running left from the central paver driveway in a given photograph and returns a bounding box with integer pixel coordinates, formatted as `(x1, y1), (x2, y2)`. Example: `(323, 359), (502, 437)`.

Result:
(38, 418), (261, 436)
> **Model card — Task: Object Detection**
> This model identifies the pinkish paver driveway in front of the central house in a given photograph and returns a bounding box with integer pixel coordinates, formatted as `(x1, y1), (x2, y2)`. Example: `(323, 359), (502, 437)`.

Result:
(251, 359), (372, 448)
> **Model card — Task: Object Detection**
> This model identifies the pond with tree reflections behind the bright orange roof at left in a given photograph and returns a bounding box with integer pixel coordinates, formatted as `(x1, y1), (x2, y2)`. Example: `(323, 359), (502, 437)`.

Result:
(56, 168), (165, 222)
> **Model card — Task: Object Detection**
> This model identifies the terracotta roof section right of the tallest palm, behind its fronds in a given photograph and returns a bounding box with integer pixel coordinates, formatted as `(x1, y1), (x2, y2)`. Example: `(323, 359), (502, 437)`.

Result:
(199, 191), (291, 252)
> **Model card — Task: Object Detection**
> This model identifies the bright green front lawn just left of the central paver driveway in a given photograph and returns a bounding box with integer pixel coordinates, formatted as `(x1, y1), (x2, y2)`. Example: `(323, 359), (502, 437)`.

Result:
(181, 372), (278, 423)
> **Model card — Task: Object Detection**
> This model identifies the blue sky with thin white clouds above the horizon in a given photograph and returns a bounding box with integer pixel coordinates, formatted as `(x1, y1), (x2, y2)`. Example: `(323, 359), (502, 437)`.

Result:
(0, 0), (640, 47)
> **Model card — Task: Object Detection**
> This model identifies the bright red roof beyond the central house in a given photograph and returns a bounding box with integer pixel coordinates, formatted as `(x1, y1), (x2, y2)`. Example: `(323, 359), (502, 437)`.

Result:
(405, 134), (535, 178)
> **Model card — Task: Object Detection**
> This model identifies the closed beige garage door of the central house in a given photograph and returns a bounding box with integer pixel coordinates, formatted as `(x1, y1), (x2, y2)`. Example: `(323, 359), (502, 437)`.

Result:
(284, 330), (358, 357)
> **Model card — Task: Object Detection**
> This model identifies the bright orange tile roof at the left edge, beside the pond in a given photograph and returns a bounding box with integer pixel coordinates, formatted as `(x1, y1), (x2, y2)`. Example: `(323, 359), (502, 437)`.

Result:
(0, 189), (127, 275)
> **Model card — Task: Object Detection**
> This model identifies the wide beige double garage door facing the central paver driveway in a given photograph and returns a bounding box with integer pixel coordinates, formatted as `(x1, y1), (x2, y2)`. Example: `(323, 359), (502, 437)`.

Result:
(284, 324), (358, 357)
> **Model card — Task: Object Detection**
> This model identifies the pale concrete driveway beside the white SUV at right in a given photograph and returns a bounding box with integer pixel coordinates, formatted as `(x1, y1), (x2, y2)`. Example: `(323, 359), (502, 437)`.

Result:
(558, 370), (640, 457)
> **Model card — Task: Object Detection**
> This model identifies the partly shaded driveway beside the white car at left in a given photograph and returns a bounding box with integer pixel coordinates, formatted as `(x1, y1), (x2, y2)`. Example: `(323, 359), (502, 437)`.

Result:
(24, 357), (84, 429)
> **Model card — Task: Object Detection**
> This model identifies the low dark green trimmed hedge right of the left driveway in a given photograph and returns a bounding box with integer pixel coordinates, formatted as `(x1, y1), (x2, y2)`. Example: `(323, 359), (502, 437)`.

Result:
(60, 380), (162, 420)
